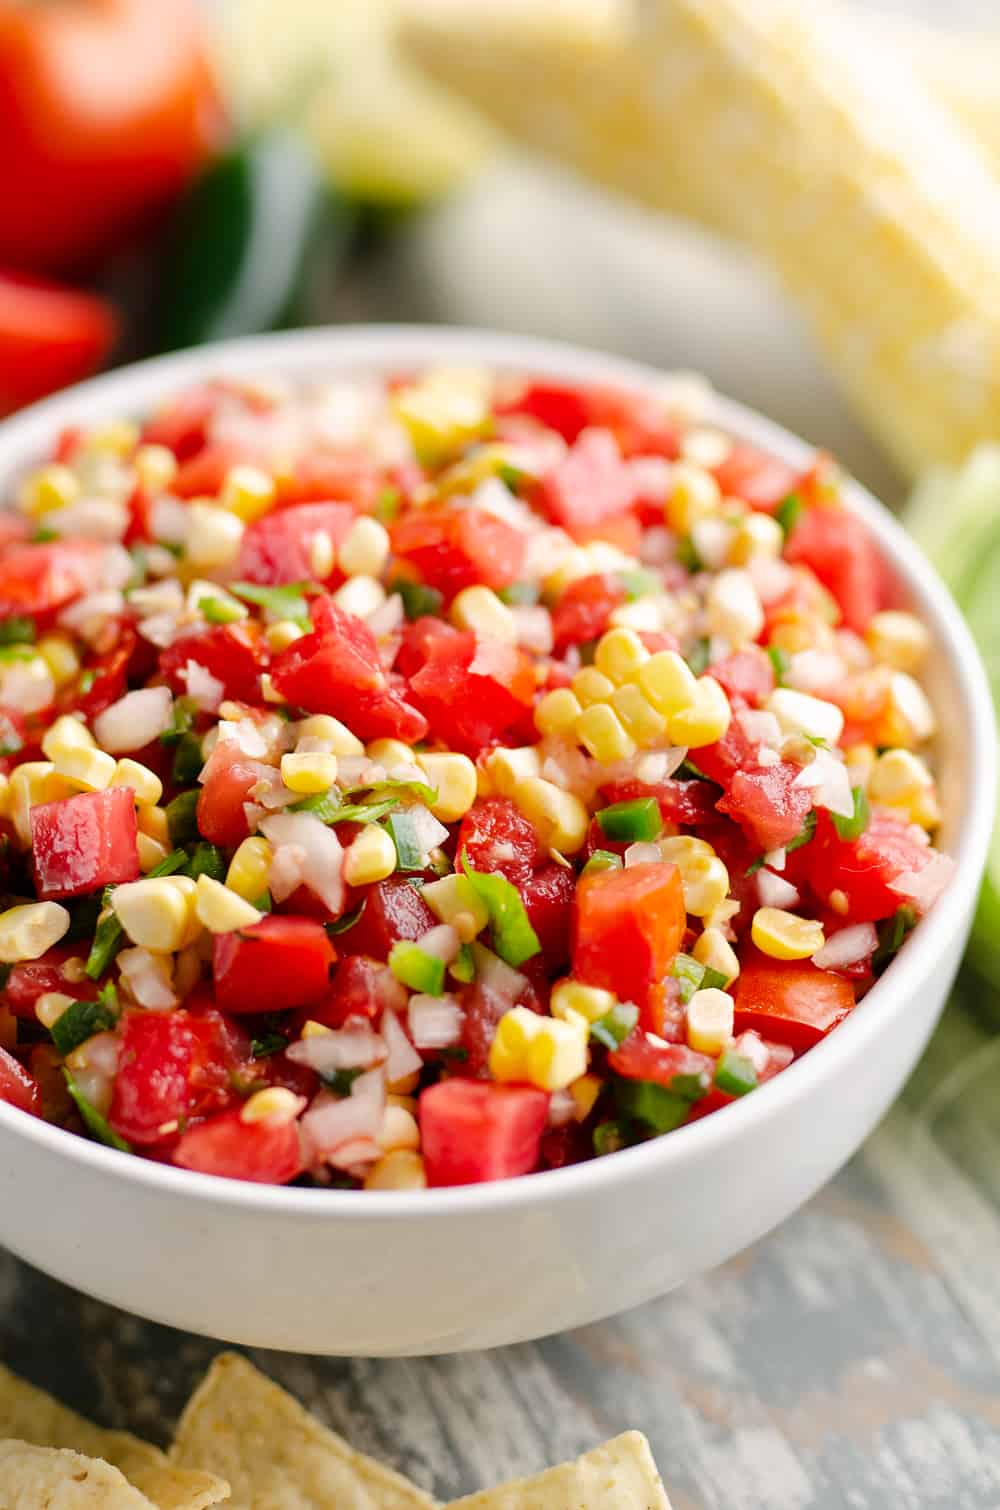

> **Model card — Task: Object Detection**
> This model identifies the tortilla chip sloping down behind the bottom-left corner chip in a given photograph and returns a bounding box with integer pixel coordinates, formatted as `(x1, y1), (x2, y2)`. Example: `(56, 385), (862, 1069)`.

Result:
(0, 1364), (230, 1510)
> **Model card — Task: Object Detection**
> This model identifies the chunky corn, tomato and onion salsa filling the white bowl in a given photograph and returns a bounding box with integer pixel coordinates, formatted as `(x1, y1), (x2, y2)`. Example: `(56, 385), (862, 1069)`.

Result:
(0, 370), (950, 1190)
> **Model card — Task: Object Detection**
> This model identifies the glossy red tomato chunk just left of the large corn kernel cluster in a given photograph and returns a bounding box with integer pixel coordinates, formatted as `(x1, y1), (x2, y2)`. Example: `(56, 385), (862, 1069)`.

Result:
(410, 634), (535, 755)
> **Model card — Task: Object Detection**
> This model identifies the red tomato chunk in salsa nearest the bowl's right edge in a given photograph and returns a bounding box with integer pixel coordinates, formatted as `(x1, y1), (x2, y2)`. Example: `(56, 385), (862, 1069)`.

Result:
(805, 808), (934, 923)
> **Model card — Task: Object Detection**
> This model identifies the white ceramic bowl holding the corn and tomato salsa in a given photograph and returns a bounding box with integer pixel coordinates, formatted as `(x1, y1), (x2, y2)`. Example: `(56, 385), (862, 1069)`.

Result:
(0, 326), (995, 1354)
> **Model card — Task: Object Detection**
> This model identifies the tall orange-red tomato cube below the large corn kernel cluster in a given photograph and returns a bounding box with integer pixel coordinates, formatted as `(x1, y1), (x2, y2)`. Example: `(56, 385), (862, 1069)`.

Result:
(573, 864), (687, 1004)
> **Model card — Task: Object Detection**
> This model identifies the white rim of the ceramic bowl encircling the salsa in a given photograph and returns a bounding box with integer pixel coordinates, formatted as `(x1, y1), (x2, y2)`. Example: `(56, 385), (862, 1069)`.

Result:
(0, 325), (997, 1222)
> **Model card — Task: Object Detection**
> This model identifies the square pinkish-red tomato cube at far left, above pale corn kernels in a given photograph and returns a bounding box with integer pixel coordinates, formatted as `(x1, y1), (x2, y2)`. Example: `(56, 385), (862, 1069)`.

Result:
(30, 787), (139, 901)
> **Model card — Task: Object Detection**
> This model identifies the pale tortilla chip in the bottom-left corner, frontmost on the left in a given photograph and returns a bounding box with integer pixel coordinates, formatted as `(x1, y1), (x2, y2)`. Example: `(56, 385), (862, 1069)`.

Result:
(0, 1441), (156, 1510)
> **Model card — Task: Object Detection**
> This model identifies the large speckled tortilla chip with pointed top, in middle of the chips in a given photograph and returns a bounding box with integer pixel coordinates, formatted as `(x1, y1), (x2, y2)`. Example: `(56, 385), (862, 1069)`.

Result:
(171, 1353), (434, 1510)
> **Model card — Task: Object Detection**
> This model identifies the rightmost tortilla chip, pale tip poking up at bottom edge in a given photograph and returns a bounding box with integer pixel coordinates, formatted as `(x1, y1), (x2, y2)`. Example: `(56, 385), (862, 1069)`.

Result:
(447, 1431), (671, 1510)
